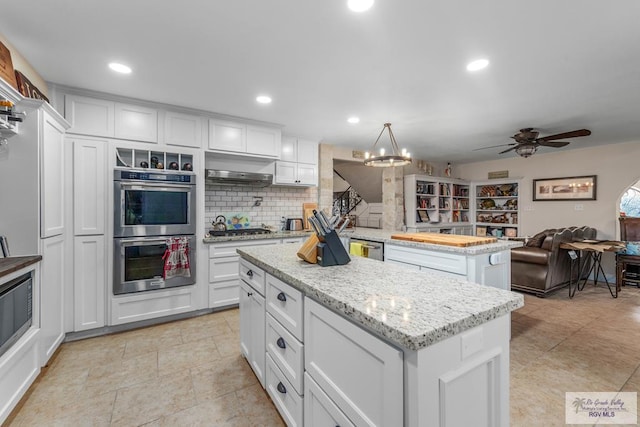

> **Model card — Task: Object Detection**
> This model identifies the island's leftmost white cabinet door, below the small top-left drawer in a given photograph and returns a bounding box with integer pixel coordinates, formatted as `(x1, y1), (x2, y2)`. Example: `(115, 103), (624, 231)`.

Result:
(240, 276), (266, 388)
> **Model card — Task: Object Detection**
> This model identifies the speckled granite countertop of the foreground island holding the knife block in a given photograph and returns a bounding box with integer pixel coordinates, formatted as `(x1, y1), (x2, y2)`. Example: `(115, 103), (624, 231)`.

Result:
(237, 245), (524, 350)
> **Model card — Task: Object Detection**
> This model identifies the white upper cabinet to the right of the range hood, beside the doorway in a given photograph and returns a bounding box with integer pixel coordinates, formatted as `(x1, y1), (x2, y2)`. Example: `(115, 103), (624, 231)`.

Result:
(274, 137), (318, 186)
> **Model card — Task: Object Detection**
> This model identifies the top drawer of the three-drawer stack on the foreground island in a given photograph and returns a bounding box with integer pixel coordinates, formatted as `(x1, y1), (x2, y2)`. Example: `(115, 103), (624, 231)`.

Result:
(266, 274), (303, 341)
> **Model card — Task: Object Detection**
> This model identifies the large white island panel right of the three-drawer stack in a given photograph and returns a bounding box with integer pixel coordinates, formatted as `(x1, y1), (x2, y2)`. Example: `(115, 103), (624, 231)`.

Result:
(304, 298), (405, 426)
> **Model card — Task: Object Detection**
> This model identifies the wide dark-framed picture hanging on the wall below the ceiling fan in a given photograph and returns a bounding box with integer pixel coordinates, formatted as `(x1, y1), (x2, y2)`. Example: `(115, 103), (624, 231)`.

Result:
(533, 175), (596, 201)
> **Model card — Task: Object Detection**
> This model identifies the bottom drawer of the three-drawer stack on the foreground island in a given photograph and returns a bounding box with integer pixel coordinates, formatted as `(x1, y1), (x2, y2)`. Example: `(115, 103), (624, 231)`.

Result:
(265, 354), (303, 427)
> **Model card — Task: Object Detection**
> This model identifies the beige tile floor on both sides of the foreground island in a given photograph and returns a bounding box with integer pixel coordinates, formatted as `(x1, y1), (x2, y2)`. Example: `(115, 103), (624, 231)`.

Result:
(8, 285), (640, 427)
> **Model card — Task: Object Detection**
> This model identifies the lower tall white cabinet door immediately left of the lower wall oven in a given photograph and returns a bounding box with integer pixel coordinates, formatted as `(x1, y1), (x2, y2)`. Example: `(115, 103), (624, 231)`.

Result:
(73, 236), (107, 331)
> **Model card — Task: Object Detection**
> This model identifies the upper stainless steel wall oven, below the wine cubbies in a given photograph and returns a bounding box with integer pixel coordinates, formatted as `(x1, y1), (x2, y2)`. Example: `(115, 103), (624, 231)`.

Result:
(113, 170), (196, 237)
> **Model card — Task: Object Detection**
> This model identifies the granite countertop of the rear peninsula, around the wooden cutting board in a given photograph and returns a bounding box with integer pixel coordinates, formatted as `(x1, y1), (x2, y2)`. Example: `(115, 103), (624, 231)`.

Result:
(342, 227), (523, 255)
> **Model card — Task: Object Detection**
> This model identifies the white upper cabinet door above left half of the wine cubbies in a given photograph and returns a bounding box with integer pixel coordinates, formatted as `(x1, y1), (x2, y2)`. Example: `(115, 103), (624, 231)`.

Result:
(115, 103), (158, 142)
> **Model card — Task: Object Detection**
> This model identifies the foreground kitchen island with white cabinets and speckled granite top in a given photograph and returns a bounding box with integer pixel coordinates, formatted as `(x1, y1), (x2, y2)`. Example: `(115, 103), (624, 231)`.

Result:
(238, 245), (523, 426)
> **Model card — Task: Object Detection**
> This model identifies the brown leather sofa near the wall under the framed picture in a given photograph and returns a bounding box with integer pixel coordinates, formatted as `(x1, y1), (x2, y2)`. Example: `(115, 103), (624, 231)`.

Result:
(511, 226), (597, 297)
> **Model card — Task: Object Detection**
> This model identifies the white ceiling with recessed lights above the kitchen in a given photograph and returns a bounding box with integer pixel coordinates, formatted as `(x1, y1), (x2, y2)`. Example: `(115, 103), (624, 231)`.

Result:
(0, 0), (640, 163)
